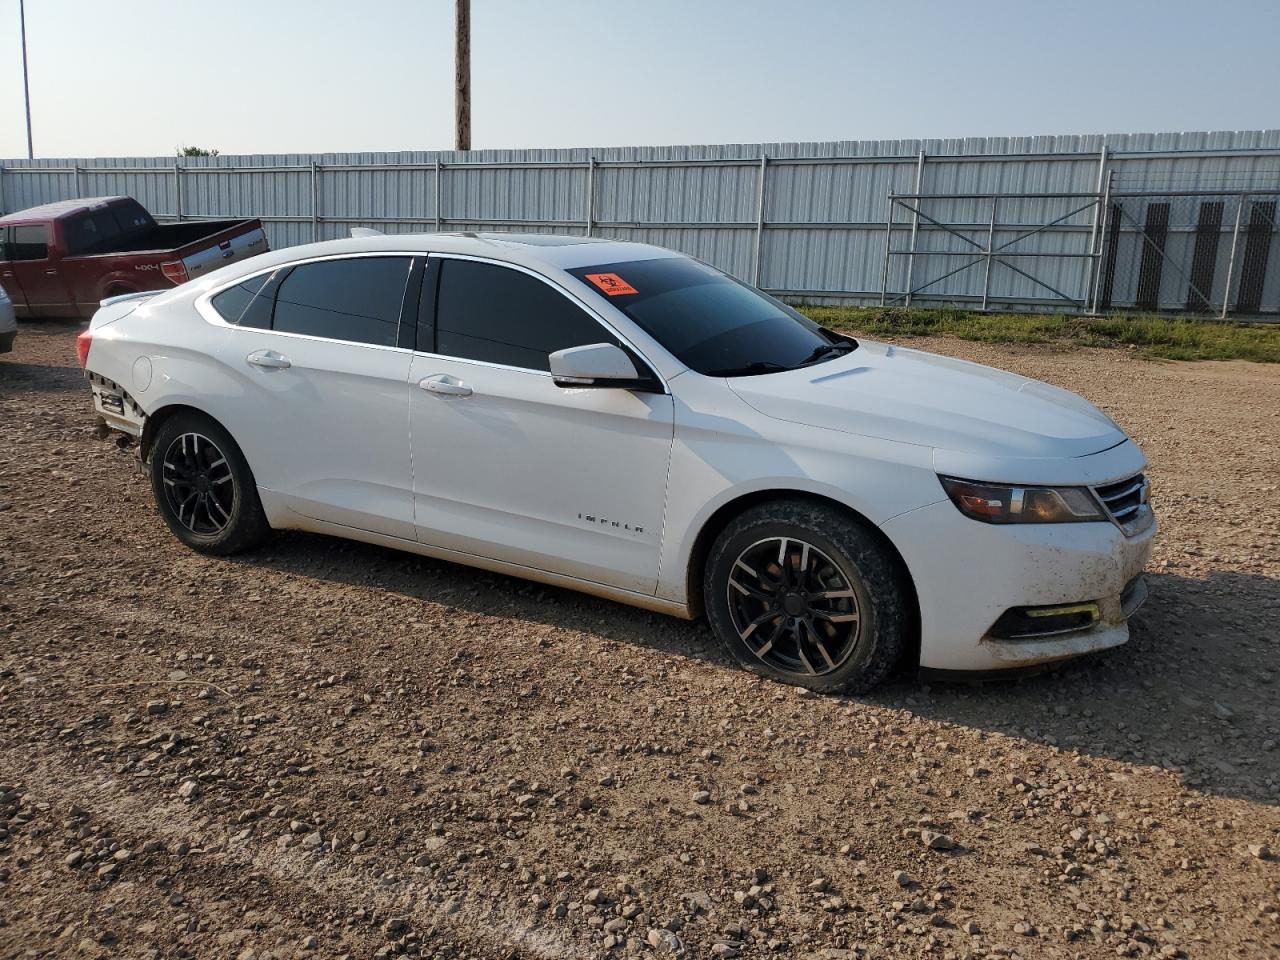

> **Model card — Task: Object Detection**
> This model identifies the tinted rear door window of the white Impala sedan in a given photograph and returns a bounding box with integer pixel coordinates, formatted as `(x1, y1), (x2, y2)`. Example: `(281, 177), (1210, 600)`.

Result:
(271, 257), (411, 347)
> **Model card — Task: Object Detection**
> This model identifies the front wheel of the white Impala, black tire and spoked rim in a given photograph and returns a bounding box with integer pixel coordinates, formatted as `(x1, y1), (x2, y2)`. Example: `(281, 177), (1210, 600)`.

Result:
(703, 499), (908, 694)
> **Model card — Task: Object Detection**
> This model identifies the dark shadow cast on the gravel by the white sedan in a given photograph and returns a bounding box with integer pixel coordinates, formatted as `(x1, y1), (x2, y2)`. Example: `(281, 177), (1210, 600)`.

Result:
(234, 531), (1280, 806)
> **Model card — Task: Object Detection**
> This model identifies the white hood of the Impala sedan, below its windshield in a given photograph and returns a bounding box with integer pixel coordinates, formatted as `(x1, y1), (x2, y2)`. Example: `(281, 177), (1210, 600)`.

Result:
(728, 342), (1125, 457)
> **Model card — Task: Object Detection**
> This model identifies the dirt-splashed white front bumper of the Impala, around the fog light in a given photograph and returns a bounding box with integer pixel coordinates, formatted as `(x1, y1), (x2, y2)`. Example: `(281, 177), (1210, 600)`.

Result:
(884, 500), (1156, 671)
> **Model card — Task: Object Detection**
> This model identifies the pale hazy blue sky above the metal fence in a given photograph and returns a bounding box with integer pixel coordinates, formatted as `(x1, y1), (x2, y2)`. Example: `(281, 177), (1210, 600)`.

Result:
(0, 0), (1280, 157)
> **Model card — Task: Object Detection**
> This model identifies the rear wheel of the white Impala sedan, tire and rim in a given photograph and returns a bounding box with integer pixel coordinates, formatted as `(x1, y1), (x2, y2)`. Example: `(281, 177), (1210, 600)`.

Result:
(151, 411), (271, 557)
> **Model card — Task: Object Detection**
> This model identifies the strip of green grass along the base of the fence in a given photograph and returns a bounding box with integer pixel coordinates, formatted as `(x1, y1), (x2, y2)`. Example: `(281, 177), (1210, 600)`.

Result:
(800, 307), (1280, 364)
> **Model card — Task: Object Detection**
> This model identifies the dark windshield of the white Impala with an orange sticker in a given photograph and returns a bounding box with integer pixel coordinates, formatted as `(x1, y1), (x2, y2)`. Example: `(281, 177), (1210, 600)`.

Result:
(568, 257), (858, 376)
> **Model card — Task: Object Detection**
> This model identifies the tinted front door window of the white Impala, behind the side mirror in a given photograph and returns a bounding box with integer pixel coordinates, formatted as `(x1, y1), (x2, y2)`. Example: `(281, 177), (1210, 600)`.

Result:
(435, 260), (617, 370)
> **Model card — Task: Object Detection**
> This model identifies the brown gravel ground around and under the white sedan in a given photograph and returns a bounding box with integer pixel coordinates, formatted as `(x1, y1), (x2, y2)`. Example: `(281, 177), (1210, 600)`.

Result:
(0, 324), (1280, 960)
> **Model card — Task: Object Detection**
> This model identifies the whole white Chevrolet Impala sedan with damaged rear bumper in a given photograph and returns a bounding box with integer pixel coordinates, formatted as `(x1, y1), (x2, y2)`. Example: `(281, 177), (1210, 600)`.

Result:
(78, 234), (1156, 690)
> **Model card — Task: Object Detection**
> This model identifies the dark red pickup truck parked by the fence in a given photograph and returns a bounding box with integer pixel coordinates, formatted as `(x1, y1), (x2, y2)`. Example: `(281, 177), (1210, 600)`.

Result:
(0, 197), (268, 317)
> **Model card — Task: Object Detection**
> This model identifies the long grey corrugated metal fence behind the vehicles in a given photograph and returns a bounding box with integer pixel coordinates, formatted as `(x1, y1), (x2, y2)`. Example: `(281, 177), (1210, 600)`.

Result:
(0, 131), (1280, 312)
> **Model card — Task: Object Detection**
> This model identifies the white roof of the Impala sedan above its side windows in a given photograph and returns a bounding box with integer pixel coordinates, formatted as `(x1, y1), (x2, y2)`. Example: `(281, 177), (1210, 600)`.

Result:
(197, 233), (684, 279)
